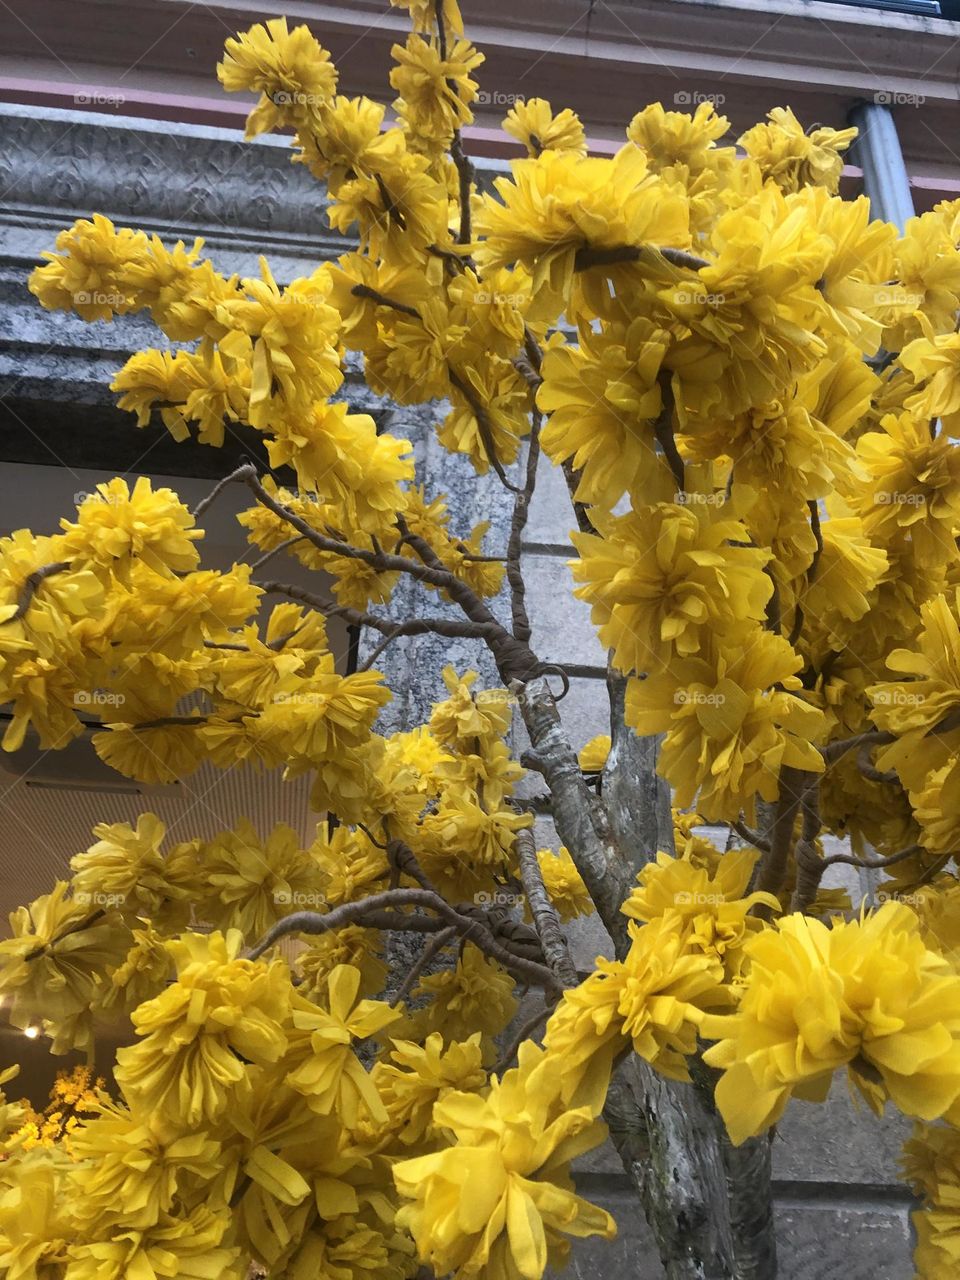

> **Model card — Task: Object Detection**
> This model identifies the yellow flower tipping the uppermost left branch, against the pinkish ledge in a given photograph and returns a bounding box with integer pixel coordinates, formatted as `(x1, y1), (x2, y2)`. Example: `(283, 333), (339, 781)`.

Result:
(216, 18), (337, 138)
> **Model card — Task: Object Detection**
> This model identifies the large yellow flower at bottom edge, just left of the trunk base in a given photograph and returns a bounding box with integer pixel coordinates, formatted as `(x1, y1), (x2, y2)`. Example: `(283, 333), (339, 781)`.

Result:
(393, 1046), (616, 1280)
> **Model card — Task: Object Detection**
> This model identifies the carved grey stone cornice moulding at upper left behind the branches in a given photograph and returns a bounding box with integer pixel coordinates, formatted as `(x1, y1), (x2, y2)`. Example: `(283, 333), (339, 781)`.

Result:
(0, 104), (344, 275)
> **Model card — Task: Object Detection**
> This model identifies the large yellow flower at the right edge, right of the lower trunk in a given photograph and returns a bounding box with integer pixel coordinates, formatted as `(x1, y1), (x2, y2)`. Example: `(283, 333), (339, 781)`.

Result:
(700, 902), (960, 1144)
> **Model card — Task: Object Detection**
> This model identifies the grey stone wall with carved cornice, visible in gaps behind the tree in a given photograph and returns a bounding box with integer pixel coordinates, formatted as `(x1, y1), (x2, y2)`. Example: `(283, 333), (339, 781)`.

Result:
(0, 106), (911, 1280)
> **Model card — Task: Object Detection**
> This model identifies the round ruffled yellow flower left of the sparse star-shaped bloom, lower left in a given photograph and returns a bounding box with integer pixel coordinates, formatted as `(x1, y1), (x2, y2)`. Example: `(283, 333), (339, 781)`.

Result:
(115, 929), (292, 1126)
